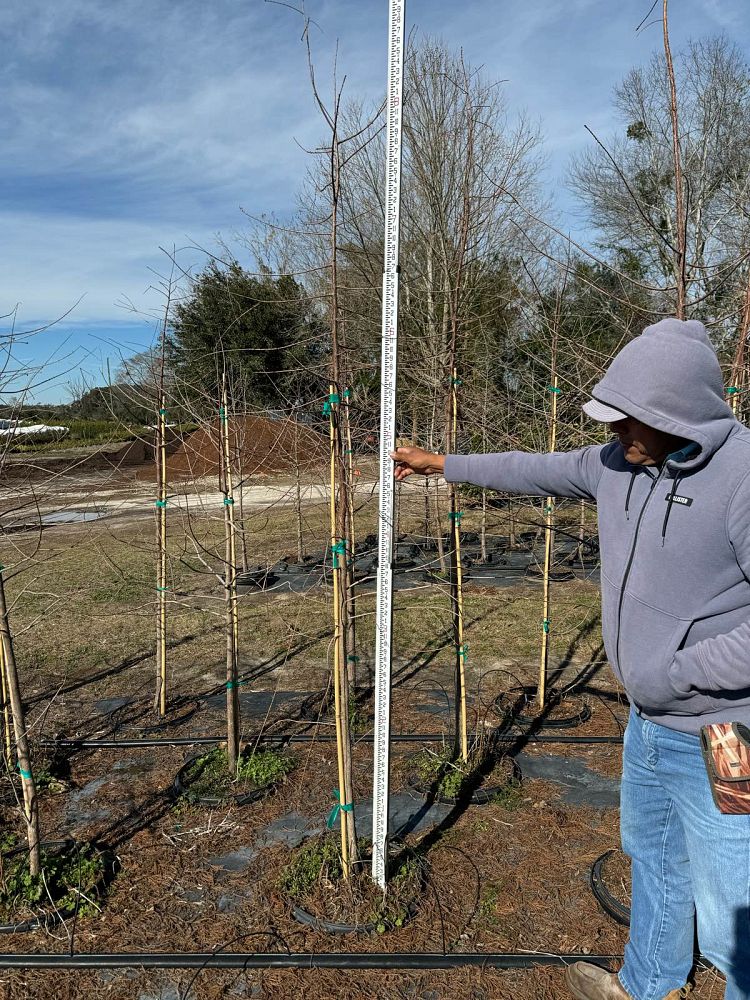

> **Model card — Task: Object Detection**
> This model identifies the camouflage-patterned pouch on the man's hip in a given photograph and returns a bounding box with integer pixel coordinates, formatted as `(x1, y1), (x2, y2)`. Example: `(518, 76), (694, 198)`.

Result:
(701, 722), (750, 813)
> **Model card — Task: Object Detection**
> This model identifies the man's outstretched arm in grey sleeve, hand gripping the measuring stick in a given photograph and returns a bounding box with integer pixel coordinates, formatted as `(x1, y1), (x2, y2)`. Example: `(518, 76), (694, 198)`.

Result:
(391, 445), (608, 500)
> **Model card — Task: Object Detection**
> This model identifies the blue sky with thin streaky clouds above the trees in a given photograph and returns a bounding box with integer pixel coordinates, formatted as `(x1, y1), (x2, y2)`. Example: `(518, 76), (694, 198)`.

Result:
(0, 0), (750, 399)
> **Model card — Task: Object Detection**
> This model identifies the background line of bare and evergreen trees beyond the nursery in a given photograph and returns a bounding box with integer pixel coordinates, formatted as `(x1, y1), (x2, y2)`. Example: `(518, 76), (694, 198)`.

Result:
(106, 32), (750, 438)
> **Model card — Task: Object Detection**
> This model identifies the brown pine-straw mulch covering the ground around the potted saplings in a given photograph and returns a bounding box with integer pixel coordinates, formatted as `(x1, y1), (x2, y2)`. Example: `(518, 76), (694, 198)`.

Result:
(0, 665), (732, 1000)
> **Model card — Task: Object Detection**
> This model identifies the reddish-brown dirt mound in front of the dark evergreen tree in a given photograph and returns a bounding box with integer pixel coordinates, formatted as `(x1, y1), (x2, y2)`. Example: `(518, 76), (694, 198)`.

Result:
(148, 417), (328, 479)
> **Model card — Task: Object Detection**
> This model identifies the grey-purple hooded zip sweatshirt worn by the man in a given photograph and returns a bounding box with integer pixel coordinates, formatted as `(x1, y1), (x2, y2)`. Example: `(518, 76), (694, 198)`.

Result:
(445, 319), (750, 733)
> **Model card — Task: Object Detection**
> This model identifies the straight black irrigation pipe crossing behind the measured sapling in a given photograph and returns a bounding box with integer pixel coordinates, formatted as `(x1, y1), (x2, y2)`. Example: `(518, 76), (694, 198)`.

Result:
(40, 733), (622, 750)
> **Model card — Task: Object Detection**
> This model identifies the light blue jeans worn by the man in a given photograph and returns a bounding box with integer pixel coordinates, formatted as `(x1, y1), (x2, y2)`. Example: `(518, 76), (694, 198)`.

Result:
(620, 710), (750, 1000)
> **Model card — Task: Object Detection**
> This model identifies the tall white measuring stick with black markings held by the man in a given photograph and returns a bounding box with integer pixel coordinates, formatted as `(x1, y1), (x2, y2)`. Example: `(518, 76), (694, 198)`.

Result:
(372, 0), (405, 889)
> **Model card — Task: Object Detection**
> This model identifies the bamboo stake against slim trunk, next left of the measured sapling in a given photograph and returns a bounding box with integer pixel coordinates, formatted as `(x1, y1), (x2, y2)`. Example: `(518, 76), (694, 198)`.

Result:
(219, 375), (240, 772)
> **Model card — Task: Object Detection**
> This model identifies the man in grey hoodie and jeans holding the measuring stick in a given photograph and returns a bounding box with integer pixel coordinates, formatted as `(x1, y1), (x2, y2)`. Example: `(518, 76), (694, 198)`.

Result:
(392, 319), (750, 1000)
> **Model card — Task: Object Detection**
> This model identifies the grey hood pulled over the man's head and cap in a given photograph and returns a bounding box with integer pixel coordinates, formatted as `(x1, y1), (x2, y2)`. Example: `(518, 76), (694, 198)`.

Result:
(591, 319), (736, 469)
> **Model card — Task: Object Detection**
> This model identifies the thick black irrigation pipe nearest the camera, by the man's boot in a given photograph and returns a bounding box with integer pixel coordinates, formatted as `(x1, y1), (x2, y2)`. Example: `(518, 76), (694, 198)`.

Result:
(0, 951), (622, 969)
